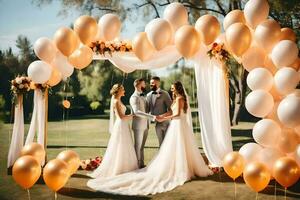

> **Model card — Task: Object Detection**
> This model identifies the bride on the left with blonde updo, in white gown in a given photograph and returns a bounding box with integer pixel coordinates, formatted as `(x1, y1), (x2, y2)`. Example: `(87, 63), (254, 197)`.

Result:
(88, 84), (138, 180)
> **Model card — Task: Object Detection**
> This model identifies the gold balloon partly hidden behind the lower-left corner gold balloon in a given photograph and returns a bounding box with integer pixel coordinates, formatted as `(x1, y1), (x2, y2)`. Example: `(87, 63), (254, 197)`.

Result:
(21, 143), (45, 165)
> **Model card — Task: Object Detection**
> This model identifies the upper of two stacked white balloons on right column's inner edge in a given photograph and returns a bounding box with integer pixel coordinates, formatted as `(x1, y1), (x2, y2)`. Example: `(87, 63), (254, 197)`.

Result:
(247, 67), (273, 91)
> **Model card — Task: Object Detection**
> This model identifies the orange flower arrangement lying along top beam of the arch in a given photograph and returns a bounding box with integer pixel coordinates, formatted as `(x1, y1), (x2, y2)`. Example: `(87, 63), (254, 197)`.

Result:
(90, 41), (132, 56)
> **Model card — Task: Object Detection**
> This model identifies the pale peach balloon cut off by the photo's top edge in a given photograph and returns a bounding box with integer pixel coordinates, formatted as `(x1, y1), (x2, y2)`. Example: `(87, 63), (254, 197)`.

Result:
(244, 0), (270, 29)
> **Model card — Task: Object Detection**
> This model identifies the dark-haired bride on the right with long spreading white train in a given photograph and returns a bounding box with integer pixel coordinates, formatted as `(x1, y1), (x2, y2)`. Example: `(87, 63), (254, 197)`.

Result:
(87, 82), (212, 195)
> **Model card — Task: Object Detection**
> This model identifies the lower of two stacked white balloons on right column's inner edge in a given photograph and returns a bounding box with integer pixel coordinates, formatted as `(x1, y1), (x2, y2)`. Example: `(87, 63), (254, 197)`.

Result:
(245, 90), (274, 117)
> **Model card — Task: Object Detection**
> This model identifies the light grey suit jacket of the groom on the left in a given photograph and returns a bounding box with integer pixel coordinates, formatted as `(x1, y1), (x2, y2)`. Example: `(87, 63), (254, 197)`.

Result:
(129, 91), (148, 130)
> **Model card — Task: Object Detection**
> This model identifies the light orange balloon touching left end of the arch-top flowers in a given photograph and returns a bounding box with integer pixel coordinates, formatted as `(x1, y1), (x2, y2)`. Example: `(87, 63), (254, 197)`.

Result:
(68, 46), (93, 70)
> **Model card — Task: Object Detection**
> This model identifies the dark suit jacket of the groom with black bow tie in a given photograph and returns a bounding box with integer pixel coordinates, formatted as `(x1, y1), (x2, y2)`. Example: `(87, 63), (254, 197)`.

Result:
(147, 90), (172, 115)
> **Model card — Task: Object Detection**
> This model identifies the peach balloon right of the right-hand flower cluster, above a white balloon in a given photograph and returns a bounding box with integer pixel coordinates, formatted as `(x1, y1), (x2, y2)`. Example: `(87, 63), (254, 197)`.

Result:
(242, 46), (266, 72)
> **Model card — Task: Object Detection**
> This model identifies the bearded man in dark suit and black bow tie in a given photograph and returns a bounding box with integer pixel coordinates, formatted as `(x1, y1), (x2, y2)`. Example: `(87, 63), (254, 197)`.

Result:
(147, 76), (172, 146)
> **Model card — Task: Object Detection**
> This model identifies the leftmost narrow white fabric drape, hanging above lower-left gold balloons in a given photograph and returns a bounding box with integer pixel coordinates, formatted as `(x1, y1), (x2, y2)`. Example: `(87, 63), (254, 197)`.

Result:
(7, 95), (24, 167)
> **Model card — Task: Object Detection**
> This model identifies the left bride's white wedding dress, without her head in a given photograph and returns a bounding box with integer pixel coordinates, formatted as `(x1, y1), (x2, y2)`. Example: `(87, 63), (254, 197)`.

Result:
(88, 99), (138, 180)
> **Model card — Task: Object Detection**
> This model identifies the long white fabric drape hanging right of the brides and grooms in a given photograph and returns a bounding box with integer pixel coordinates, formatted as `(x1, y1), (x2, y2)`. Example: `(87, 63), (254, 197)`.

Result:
(192, 46), (232, 167)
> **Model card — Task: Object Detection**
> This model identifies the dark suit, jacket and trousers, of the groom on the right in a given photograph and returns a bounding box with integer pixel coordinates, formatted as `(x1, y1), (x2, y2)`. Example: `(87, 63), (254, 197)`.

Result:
(147, 90), (172, 146)
